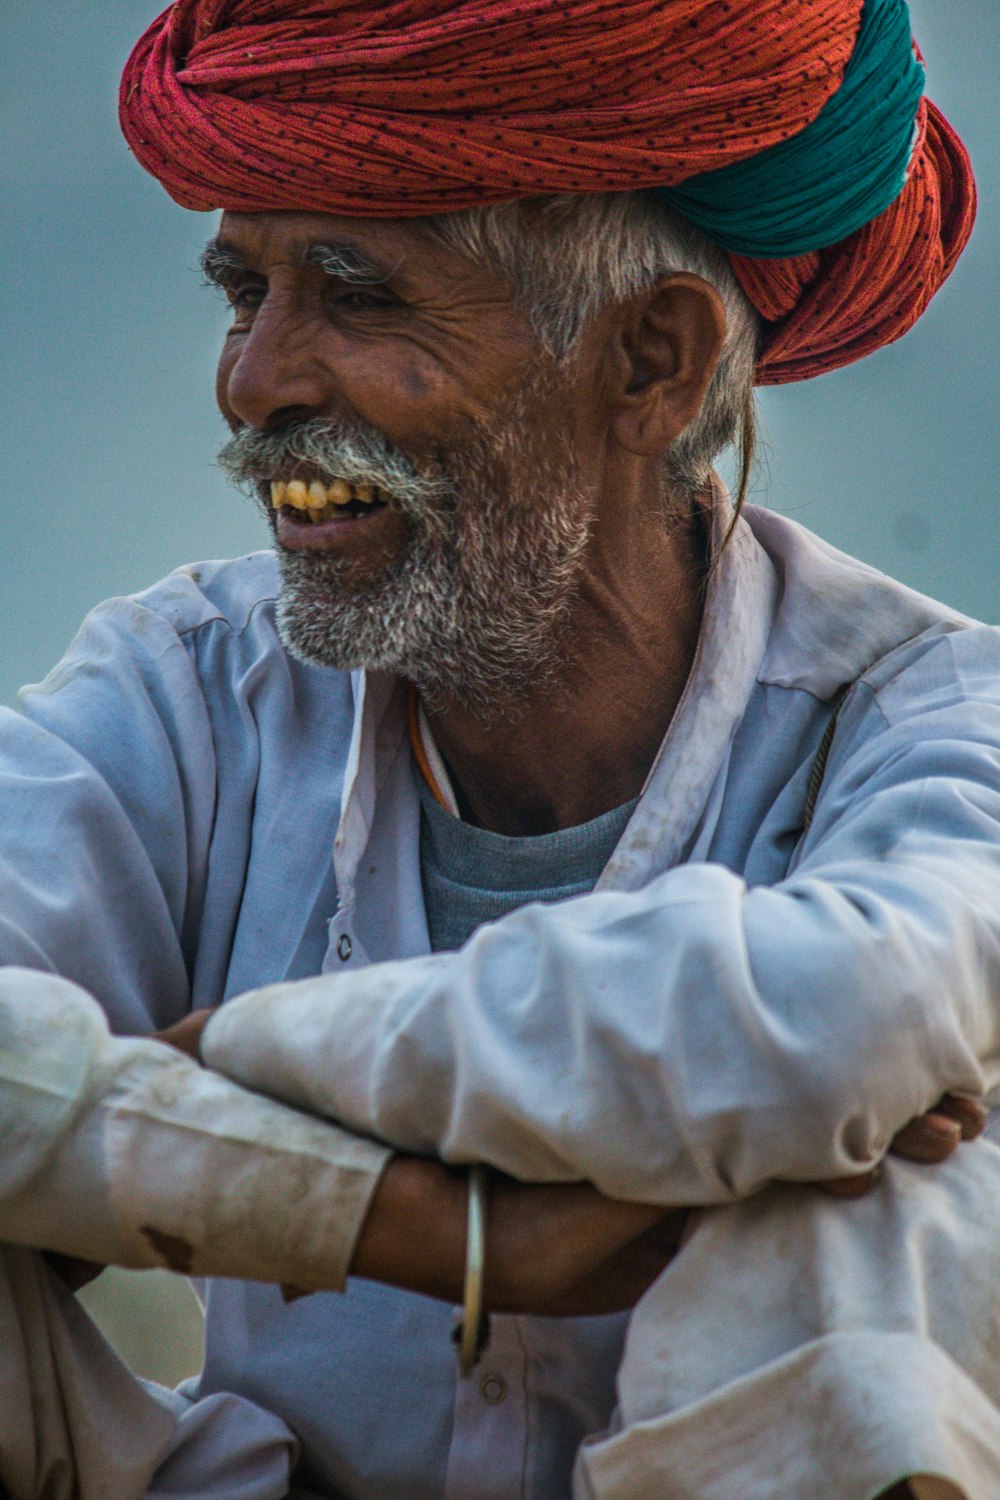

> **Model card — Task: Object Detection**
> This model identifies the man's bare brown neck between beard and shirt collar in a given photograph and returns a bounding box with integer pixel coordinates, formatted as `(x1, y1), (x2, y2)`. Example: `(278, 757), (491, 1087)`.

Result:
(427, 498), (708, 834)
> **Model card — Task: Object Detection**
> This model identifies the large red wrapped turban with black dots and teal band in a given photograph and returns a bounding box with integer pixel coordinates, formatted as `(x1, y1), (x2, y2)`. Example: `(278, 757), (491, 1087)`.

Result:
(120, 0), (976, 384)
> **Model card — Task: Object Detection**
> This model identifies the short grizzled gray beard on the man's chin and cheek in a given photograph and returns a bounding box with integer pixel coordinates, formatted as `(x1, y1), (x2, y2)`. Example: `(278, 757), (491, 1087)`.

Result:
(268, 369), (591, 716)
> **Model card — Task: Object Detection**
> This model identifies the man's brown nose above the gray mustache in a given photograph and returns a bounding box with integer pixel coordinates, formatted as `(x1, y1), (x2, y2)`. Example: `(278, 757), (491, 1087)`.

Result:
(217, 296), (331, 428)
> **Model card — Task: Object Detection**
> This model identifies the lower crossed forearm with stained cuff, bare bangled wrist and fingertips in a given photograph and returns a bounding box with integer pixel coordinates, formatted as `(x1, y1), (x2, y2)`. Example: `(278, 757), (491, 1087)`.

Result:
(0, 968), (978, 1313)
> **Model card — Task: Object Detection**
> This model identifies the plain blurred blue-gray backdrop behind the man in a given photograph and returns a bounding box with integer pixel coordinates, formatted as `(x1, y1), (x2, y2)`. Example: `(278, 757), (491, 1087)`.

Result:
(0, 0), (1000, 1379)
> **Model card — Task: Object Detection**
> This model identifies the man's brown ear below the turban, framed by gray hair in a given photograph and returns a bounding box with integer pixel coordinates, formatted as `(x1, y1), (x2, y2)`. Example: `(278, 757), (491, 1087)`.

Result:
(610, 272), (726, 458)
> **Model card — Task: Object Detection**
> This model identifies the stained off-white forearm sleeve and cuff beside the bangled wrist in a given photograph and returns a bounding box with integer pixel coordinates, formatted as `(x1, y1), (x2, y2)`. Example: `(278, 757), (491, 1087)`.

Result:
(0, 968), (388, 1290)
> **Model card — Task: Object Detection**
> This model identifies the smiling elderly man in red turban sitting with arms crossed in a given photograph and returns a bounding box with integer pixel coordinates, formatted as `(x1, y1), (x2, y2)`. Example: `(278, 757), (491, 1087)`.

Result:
(3, 0), (1000, 1500)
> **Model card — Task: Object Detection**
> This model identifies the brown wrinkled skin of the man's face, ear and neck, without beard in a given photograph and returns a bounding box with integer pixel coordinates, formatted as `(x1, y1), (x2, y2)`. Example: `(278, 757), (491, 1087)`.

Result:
(217, 213), (724, 834)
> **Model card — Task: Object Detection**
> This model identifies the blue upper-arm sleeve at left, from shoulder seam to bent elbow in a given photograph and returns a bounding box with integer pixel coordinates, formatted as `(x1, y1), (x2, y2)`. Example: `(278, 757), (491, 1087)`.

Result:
(0, 600), (217, 1032)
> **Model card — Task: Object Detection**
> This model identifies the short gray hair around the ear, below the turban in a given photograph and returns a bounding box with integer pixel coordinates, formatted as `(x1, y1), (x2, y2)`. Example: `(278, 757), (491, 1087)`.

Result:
(424, 191), (760, 509)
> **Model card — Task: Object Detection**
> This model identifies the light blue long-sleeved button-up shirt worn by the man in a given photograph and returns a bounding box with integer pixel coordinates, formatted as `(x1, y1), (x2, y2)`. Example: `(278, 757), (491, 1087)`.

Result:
(0, 510), (1000, 1500)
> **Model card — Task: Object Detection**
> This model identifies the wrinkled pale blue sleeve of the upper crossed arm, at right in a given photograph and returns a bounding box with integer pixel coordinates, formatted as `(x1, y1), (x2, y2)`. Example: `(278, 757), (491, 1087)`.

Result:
(202, 632), (1000, 1205)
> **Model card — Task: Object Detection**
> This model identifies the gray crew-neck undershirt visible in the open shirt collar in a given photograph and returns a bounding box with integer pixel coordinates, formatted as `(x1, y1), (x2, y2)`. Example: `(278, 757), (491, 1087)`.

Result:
(420, 779), (639, 953)
